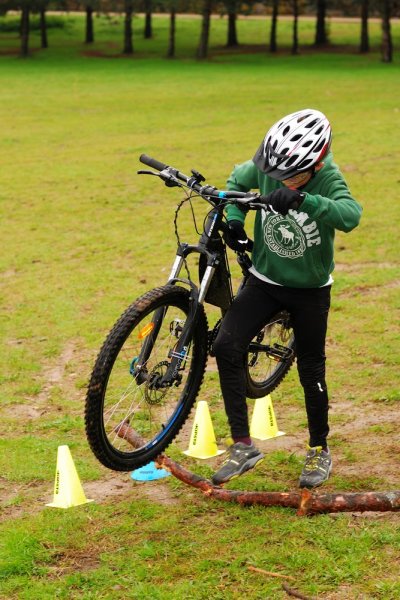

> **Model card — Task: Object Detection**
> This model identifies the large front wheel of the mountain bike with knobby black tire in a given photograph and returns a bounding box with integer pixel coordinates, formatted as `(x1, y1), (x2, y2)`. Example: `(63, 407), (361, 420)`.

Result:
(85, 285), (207, 471)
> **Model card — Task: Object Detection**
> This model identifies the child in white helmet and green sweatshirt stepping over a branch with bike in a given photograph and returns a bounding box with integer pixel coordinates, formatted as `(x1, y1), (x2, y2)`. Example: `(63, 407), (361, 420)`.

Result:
(212, 109), (362, 488)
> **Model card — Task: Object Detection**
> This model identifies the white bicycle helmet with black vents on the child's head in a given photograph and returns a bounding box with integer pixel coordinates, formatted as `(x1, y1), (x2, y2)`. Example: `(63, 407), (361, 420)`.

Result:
(253, 108), (332, 181)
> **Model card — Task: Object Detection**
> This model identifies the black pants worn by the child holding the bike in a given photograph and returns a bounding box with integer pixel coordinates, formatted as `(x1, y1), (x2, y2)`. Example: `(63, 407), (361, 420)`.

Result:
(213, 275), (330, 446)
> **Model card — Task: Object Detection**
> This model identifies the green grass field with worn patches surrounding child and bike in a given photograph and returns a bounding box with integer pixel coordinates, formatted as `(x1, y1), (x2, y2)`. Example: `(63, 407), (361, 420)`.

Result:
(0, 12), (400, 600)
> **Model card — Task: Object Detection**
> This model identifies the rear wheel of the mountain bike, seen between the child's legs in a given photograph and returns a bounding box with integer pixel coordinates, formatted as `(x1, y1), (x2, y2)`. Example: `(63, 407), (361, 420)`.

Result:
(246, 311), (296, 398)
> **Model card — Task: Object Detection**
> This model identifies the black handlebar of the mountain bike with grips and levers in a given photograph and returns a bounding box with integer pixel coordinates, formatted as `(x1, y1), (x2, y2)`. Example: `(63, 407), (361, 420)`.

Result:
(139, 154), (260, 208)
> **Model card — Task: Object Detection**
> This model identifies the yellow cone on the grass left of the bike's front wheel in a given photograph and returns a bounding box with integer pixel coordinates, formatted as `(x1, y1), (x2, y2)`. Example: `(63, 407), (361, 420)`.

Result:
(46, 446), (93, 508)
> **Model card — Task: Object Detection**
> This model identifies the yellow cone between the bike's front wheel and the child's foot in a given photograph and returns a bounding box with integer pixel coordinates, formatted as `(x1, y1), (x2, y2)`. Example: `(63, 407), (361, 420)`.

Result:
(184, 400), (224, 458)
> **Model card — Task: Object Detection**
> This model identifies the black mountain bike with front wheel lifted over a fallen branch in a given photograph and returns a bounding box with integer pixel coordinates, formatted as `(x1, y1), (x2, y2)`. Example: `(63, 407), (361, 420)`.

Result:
(85, 154), (295, 471)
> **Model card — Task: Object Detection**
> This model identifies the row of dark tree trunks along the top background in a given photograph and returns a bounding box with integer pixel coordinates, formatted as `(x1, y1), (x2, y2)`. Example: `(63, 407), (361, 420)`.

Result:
(0, 0), (400, 62)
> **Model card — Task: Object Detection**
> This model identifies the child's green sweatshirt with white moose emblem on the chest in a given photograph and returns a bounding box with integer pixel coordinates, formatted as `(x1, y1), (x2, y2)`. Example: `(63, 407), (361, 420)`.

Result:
(227, 153), (362, 288)
